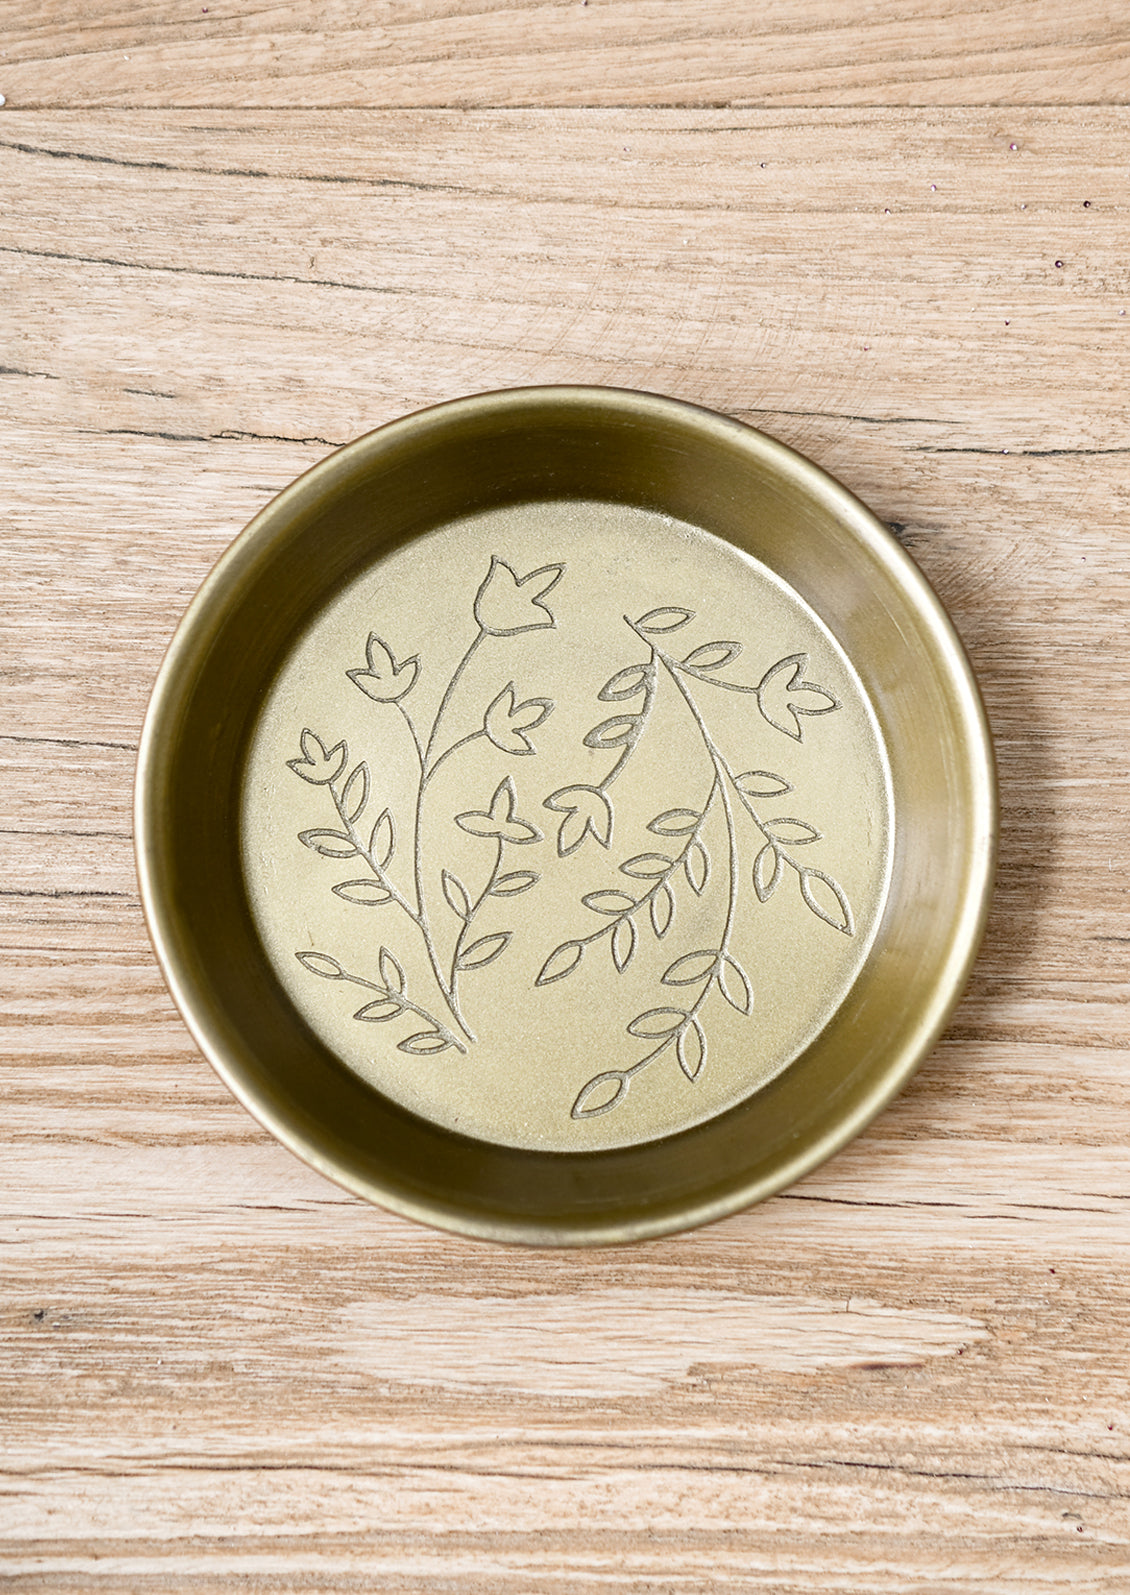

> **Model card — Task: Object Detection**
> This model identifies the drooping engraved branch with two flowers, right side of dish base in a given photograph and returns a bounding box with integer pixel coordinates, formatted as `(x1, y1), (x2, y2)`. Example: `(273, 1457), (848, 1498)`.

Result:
(535, 606), (854, 1118)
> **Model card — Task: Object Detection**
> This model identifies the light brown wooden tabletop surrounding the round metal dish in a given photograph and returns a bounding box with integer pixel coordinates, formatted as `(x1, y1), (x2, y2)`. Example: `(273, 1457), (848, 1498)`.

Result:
(0, 0), (1130, 1595)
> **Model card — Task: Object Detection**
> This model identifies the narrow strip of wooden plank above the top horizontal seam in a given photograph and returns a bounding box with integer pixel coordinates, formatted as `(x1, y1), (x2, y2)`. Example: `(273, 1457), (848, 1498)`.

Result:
(0, 0), (1130, 108)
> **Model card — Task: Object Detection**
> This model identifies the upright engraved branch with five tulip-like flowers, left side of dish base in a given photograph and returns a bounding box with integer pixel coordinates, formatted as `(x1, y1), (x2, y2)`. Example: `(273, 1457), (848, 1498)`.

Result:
(287, 555), (565, 1056)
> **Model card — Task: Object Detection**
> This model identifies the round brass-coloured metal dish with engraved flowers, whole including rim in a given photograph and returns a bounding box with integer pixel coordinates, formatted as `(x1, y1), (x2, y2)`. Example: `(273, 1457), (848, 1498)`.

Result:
(137, 388), (996, 1244)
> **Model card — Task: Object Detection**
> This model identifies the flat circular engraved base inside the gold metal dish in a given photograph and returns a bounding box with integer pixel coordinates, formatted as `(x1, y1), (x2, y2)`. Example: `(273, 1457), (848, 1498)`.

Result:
(241, 499), (892, 1153)
